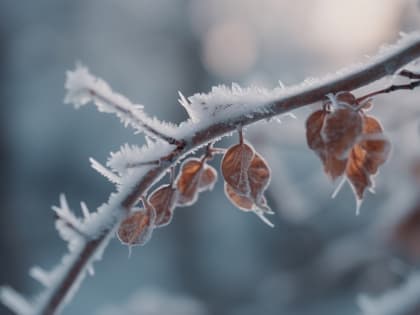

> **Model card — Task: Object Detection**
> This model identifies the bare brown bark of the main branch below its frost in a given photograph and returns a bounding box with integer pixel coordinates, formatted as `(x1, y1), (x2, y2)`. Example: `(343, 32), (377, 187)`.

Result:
(7, 34), (420, 315)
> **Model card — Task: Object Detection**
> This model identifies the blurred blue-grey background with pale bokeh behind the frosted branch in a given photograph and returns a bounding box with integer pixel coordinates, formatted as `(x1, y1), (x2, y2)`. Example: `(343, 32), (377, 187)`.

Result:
(0, 0), (420, 315)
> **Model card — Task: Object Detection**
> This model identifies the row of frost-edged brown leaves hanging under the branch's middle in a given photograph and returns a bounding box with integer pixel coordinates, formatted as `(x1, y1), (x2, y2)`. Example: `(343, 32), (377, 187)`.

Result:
(117, 136), (273, 246)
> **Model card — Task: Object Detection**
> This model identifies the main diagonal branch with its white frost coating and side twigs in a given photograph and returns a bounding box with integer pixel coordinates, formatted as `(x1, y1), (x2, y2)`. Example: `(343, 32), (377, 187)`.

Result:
(0, 33), (420, 315)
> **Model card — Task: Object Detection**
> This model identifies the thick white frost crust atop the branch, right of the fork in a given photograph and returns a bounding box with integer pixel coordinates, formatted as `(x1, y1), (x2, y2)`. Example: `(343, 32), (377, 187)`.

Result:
(178, 32), (420, 137)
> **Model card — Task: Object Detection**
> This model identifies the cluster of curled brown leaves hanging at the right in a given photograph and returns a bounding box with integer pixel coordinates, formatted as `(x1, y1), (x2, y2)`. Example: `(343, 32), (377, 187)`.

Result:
(306, 92), (390, 210)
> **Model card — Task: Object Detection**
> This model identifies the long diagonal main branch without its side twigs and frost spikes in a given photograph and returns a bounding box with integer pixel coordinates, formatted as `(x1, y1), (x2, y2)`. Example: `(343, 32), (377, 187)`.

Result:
(1, 34), (420, 315)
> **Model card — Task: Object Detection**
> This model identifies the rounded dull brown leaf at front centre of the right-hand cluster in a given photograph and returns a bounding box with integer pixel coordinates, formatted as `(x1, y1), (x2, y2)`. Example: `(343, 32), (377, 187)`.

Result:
(321, 108), (363, 159)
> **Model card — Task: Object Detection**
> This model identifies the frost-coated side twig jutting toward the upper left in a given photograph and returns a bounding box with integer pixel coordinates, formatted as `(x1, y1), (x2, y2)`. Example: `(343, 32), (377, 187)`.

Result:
(64, 65), (178, 144)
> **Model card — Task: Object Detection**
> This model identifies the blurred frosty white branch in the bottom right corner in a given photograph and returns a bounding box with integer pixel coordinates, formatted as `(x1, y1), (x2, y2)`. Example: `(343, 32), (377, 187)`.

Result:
(358, 272), (420, 315)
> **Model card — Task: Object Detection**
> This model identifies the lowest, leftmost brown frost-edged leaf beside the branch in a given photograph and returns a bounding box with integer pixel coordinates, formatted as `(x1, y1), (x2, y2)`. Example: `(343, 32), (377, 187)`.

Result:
(117, 207), (156, 246)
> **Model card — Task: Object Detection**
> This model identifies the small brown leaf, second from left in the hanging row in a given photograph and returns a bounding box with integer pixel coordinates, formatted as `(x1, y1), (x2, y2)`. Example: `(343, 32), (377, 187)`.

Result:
(148, 185), (177, 227)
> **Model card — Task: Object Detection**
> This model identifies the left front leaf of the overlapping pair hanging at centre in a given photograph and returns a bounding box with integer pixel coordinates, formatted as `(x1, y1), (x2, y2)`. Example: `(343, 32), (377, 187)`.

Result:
(222, 143), (254, 196)
